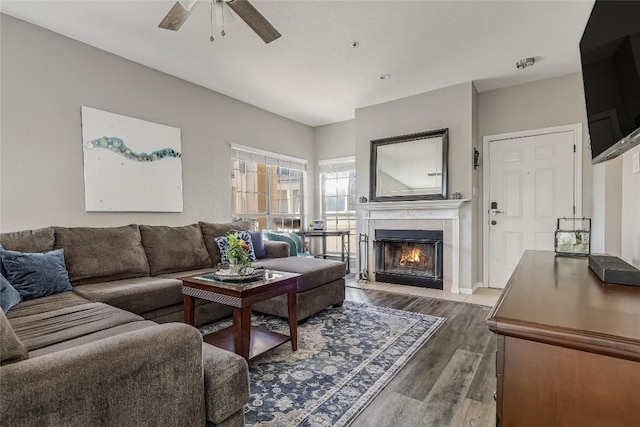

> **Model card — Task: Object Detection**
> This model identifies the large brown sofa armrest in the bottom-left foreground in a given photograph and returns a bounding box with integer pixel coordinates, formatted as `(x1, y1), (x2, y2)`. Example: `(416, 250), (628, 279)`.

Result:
(0, 323), (205, 426)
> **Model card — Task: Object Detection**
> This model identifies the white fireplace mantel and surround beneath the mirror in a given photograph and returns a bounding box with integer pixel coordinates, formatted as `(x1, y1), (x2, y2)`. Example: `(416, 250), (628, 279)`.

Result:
(356, 199), (468, 293)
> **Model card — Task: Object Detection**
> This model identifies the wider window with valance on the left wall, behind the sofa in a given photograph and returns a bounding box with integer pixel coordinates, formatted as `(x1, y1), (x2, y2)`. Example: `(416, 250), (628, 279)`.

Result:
(231, 145), (306, 231)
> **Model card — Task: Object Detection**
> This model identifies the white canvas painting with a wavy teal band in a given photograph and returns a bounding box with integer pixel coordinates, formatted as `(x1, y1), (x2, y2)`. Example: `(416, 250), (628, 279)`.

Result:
(82, 106), (182, 212)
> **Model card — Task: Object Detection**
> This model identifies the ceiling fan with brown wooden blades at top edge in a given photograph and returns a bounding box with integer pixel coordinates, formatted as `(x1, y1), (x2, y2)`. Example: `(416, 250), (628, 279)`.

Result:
(158, 0), (280, 43)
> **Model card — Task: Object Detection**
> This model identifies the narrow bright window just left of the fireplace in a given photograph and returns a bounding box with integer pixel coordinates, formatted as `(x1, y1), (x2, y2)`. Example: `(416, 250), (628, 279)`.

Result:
(318, 157), (357, 254)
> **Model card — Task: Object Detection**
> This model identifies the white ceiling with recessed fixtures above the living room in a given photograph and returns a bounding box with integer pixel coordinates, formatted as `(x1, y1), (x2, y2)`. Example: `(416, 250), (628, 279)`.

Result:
(0, 0), (594, 126)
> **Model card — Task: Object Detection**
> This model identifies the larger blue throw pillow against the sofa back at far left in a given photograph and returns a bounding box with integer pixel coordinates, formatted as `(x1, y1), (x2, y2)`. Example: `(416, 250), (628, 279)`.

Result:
(0, 249), (73, 301)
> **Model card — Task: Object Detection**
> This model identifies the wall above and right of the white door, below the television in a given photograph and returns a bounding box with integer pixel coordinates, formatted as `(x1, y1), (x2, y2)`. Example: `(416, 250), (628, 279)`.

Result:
(478, 73), (640, 267)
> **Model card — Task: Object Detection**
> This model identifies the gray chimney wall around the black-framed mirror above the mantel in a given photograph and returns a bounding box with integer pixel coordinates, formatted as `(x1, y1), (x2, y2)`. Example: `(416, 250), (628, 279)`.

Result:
(355, 82), (477, 289)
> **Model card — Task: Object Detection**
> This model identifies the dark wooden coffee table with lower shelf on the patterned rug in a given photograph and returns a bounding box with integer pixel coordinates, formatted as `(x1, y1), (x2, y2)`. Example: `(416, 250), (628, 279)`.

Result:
(180, 270), (302, 360)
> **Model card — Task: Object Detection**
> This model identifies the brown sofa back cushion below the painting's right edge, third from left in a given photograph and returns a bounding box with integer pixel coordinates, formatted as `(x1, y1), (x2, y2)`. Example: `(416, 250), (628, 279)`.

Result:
(140, 224), (211, 276)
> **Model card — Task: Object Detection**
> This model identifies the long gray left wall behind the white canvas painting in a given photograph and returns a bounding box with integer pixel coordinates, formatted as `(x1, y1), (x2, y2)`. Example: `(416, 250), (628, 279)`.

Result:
(0, 15), (316, 231)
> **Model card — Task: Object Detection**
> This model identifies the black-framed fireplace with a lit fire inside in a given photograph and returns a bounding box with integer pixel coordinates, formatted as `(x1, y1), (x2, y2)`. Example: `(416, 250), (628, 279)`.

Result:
(373, 229), (443, 289)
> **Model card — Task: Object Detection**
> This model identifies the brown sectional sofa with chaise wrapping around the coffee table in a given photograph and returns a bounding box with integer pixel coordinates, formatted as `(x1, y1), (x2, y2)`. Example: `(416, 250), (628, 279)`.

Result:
(0, 222), (345, 427)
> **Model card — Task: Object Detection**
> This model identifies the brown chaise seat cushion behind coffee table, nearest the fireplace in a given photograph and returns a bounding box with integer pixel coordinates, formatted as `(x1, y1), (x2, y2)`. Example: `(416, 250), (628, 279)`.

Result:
(253, 257), (347, 292)
